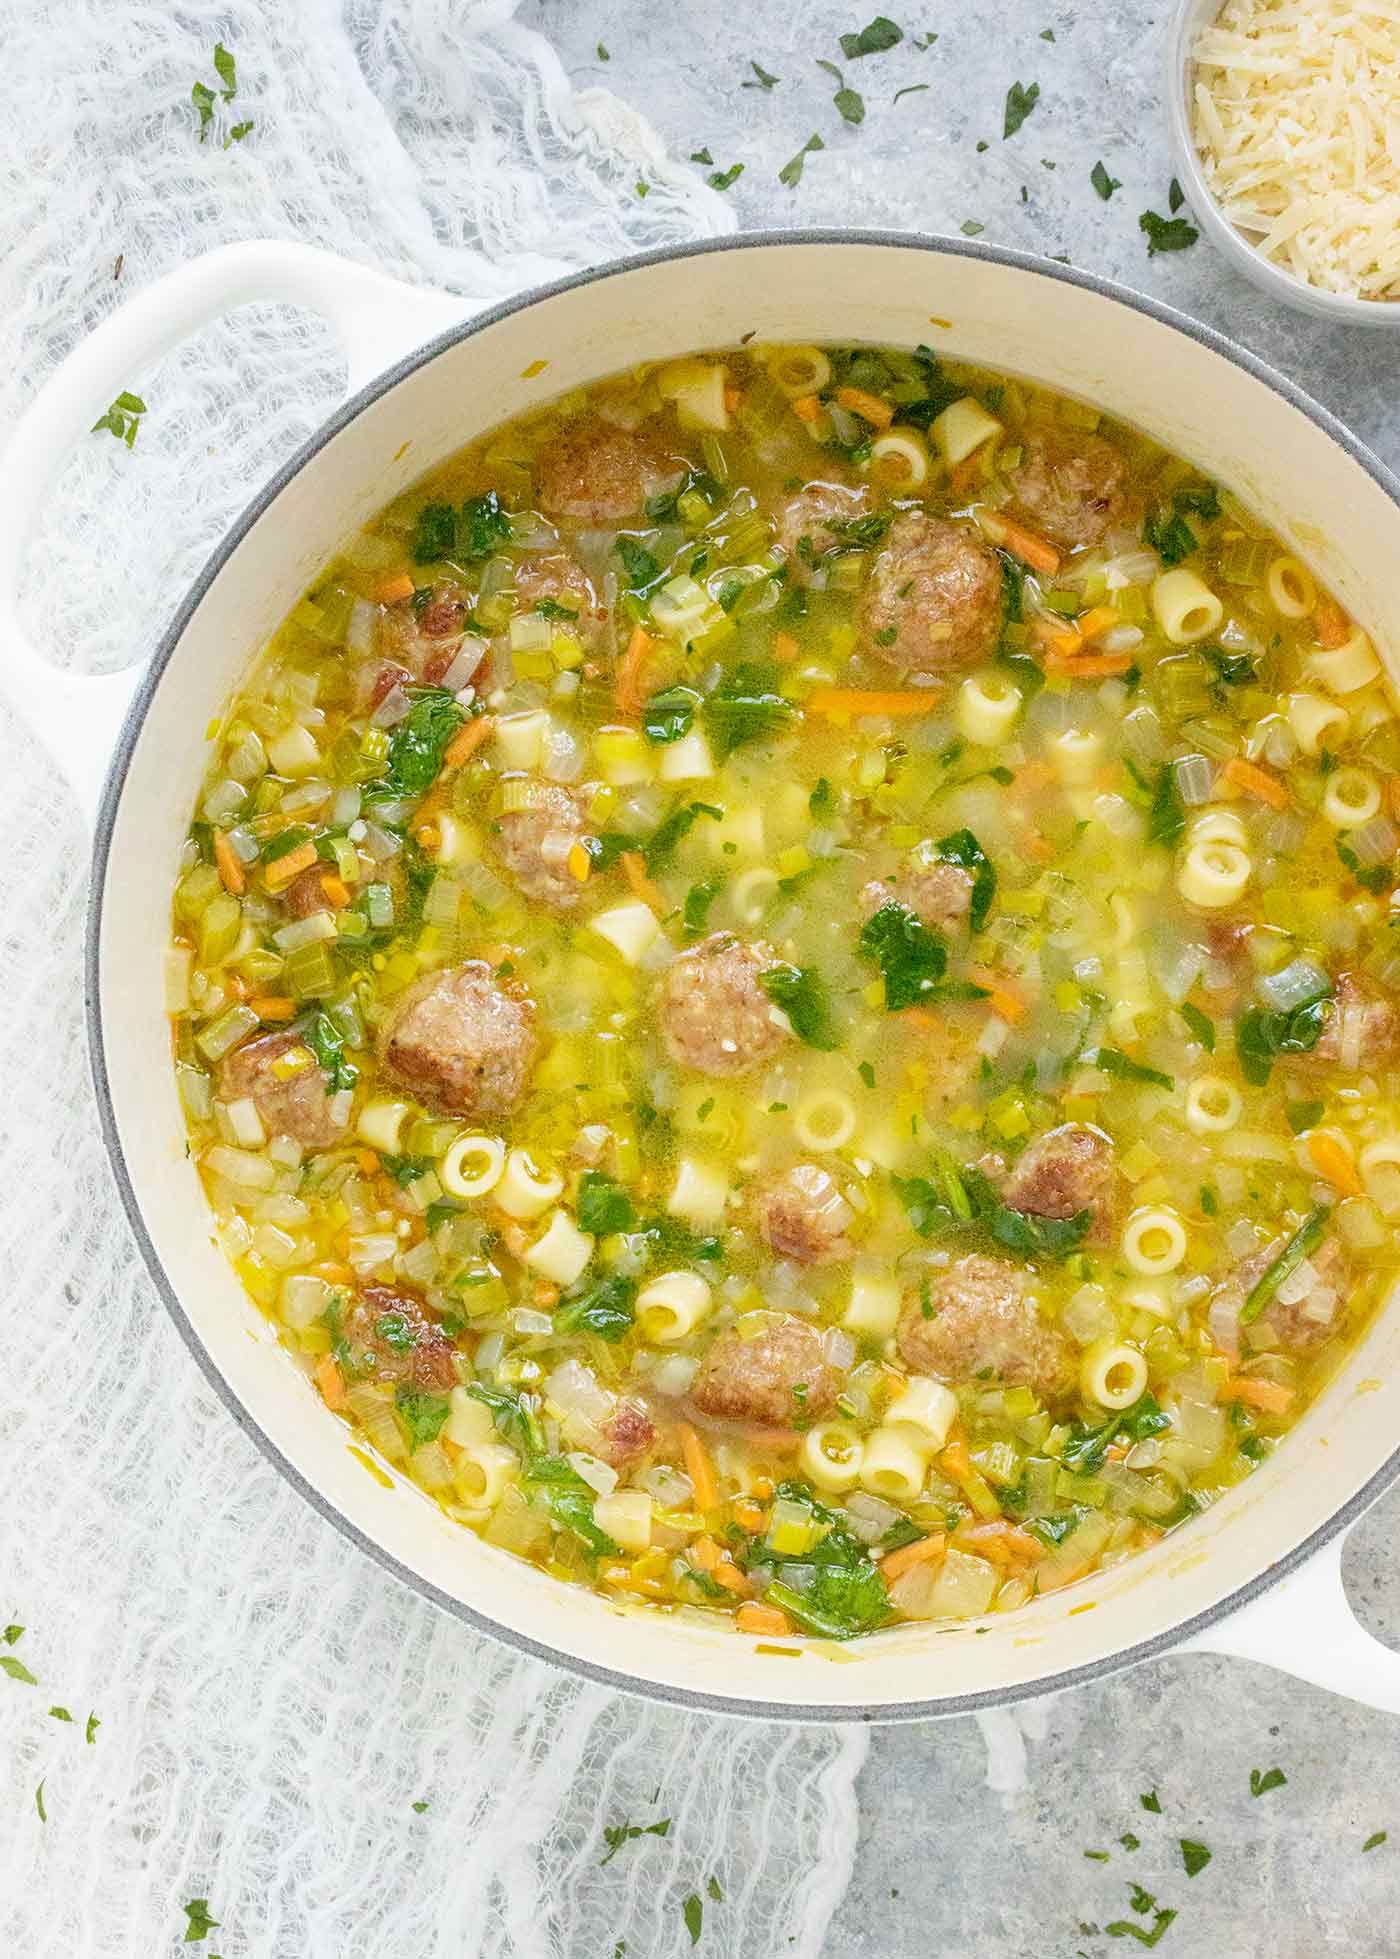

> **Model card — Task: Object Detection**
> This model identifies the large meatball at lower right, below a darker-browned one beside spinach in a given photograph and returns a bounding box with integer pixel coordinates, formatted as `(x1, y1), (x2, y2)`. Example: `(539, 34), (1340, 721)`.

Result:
(895, 1252), (1071, 1397)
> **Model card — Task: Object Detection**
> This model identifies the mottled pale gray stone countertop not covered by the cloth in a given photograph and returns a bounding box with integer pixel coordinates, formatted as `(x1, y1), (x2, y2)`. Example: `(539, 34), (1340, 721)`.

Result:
(521, 0), (1400, 1959)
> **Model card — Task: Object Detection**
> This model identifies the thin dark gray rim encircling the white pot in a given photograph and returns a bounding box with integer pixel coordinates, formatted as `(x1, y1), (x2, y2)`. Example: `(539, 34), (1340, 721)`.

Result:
(84, 229), (1400, 1724)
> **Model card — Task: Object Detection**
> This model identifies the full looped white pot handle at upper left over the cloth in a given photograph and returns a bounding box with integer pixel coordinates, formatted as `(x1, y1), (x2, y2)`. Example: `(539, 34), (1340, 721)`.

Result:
(0, 239), (468, 823)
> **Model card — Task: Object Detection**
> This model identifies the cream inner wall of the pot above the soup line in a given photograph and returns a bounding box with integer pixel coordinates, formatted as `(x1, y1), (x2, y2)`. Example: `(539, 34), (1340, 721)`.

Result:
(98, 241), (1400, 1714)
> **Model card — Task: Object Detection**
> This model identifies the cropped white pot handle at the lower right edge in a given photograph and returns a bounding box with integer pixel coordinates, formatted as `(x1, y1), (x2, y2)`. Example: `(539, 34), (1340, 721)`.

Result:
(1175, 1530), (1400, 1714)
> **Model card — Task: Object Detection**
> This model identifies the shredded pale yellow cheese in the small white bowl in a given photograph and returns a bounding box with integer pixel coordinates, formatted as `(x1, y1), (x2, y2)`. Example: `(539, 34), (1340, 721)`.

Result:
(1190, 0), (1400, 300)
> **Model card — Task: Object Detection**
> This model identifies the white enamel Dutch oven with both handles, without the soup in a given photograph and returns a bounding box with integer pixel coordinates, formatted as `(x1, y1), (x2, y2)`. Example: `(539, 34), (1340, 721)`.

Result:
(0, 233), (1400, 1720)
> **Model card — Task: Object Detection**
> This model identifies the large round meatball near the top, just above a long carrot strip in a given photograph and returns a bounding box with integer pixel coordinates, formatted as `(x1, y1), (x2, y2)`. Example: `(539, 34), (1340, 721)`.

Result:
(862, 509), (1003, 674)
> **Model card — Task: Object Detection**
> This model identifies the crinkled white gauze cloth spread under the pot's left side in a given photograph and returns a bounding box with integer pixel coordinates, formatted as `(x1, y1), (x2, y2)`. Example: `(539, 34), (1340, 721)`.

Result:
(0, 0), (877, 1959)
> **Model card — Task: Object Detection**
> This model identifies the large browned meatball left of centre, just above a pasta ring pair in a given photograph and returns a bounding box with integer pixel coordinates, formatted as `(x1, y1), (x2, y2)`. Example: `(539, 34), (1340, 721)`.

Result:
(378, 960), (537, 1117)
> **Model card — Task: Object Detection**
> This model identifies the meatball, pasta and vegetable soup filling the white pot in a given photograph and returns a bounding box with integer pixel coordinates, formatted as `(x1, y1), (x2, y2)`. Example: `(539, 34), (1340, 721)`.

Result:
(168, 347), (1400, 1640)
